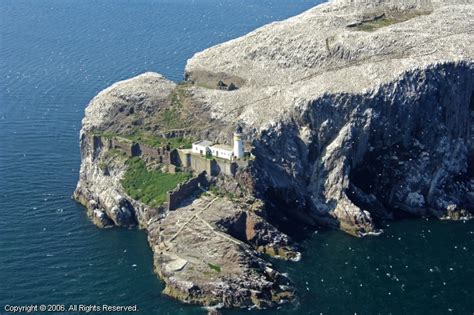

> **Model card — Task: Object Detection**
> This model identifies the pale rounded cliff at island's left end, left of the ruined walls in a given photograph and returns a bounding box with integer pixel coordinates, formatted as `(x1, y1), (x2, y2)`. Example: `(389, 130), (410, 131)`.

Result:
(74, 73), (175, 227)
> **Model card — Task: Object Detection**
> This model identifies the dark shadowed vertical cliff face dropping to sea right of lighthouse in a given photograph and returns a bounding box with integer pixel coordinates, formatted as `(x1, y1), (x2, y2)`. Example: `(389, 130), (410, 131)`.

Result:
(248, 62), (474, 233)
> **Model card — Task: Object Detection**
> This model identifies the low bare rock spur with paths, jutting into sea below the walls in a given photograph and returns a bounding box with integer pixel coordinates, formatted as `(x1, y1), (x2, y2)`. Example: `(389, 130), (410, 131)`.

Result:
(148, 195), (295, 307)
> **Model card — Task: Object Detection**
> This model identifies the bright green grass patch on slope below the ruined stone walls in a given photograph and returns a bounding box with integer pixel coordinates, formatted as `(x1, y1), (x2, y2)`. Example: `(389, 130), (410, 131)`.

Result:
(121, 157), (191, 207)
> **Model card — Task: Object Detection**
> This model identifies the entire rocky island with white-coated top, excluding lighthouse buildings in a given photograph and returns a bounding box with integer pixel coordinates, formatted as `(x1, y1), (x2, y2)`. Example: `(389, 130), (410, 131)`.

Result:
(74, 0), (474, 307)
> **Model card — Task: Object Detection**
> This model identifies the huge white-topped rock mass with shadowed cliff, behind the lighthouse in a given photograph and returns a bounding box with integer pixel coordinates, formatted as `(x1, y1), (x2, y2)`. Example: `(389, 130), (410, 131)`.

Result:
(186, 1), (474, 234)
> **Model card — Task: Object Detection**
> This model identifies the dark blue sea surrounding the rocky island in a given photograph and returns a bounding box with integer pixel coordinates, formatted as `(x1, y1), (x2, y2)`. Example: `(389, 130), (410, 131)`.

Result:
(0, 0), (474, 314)
